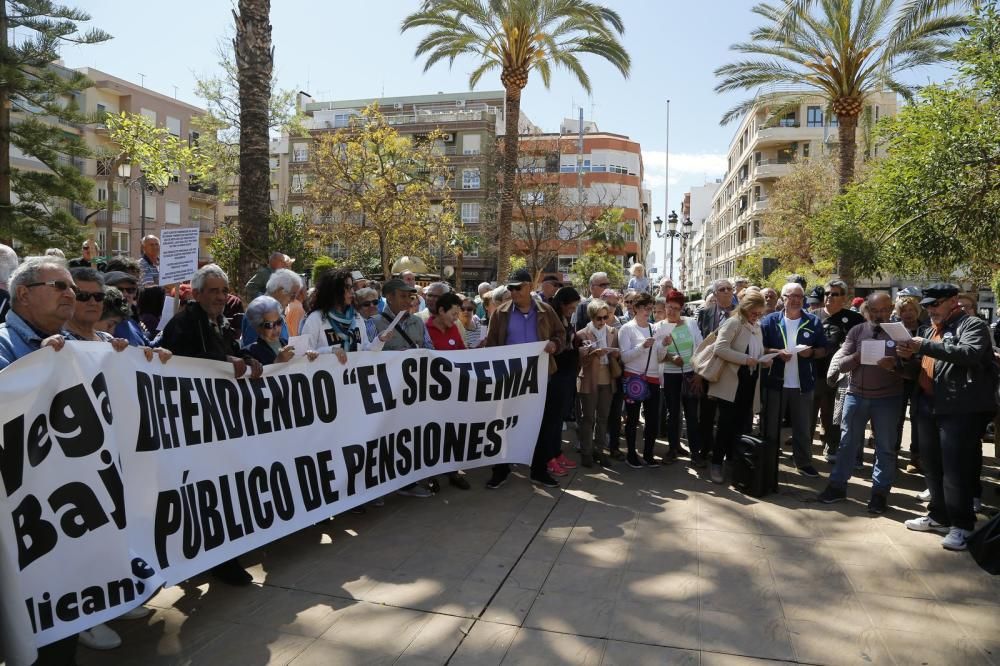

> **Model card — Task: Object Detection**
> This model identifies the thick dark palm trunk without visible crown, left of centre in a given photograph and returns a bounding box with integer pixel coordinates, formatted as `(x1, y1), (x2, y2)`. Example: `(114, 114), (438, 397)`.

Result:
(233, 0), (277, 291)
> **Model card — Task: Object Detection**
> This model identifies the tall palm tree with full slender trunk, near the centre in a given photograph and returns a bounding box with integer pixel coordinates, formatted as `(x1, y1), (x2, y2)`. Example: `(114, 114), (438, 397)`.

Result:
(401, 0), (631, 279)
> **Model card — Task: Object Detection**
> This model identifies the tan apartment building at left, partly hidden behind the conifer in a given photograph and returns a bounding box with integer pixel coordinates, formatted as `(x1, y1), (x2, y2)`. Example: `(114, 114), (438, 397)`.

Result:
(77, 67), (216, 261)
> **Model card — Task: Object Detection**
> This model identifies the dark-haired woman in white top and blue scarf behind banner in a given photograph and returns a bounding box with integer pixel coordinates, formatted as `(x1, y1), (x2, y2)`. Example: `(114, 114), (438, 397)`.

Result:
(302, 270), (391, 363)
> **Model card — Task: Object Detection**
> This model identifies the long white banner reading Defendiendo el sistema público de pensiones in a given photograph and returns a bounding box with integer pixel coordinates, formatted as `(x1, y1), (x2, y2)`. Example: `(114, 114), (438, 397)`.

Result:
(0, 342), (548, 665)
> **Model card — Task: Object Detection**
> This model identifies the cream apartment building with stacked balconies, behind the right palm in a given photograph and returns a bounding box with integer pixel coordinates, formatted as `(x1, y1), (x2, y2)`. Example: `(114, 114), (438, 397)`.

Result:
(697, 90), (897, 287)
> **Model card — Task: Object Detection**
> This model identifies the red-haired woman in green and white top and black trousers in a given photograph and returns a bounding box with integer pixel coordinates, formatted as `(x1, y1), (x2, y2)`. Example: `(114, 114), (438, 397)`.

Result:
(657, 289), (702, 462)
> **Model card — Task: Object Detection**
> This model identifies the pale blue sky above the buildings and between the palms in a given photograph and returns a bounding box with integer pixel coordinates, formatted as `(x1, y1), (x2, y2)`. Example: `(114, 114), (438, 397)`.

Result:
(64, 0), (946, 244)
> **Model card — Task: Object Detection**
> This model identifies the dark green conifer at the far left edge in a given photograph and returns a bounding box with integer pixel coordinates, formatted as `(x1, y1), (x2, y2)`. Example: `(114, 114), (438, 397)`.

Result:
(0, 0), (111, 252)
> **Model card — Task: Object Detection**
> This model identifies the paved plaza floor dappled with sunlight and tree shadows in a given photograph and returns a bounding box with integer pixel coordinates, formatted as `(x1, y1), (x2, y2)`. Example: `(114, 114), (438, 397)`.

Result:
(79, 431), (1000, 666)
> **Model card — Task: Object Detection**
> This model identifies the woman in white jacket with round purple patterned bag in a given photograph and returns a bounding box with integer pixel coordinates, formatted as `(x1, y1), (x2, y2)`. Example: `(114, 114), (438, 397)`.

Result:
(618, 293), (668, 469)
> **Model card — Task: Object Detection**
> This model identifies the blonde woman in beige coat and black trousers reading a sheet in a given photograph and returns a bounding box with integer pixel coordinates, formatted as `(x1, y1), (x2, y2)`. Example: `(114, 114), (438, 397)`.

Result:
(708, 292), (771, 483)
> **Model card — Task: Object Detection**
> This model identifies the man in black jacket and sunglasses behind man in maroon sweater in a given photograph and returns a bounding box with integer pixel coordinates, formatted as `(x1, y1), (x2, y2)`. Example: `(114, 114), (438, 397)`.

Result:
(810, 280), (865, 463)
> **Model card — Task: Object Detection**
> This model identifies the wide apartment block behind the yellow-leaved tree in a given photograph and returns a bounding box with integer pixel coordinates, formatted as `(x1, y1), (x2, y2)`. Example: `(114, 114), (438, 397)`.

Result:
(271, 90), (537, 292)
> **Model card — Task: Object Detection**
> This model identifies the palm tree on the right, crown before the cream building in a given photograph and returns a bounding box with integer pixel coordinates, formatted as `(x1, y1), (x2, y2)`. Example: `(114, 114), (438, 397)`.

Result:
(715, 0), (968, 281)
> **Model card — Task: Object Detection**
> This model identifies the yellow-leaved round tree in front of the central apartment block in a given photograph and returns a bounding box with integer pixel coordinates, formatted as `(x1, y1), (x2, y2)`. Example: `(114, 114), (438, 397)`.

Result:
(307, 106), (456, 277)
